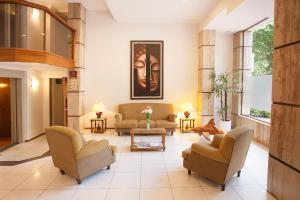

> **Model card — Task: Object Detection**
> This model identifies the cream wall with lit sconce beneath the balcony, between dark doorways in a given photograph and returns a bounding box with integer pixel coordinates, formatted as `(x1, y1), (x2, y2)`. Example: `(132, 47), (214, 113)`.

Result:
(0, 63), (67, 140)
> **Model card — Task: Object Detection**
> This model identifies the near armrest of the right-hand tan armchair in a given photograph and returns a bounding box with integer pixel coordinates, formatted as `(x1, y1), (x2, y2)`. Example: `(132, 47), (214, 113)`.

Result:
(191, 143), (229, 163)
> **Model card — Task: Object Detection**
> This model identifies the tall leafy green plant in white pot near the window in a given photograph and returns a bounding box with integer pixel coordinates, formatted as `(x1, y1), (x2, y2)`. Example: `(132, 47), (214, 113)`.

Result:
(209, 71), (239, 132)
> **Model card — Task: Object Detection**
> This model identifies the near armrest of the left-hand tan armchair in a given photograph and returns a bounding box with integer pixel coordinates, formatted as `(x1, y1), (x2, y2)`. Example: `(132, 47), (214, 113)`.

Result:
(76, 140), (113, 160)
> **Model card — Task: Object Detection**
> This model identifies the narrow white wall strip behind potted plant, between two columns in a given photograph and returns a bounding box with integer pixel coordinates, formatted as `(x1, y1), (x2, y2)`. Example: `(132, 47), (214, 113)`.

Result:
(214, 31), (233, 122)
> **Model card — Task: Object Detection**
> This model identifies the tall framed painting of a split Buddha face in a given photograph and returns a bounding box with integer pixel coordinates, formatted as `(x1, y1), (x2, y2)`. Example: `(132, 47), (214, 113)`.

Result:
(130, 41), (164, 99)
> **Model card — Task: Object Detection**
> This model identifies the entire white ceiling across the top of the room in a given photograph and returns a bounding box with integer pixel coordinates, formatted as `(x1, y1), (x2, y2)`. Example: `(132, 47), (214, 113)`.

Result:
(30, 0), (274, 32)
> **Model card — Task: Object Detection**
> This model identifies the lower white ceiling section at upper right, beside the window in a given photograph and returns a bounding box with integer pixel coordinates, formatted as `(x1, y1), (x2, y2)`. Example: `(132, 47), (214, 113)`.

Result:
(204, 0), (274, 32)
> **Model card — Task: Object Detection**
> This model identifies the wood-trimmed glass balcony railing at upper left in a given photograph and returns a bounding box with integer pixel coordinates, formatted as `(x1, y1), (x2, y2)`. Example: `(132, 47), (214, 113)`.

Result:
(0, 0), (75, 59)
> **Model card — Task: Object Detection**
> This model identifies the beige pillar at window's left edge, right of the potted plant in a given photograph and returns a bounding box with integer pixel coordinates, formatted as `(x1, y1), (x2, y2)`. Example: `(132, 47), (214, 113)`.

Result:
(231, 31), (252, 128)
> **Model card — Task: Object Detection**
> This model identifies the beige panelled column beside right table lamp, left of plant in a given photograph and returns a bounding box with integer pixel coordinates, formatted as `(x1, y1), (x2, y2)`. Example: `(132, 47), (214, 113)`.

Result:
(198, 30), (216, 124)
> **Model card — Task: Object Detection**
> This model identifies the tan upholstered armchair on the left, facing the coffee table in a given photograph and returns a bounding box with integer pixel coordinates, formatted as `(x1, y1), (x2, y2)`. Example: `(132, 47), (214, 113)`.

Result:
(46, 126), (116, 184)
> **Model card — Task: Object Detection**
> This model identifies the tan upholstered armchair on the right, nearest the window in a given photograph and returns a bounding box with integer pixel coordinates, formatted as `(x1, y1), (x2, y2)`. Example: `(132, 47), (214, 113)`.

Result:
(182, 126), (253, 191)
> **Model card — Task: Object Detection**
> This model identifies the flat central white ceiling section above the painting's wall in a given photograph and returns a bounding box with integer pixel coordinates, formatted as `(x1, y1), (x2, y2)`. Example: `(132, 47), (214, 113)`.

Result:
(106, 0), (219, 23)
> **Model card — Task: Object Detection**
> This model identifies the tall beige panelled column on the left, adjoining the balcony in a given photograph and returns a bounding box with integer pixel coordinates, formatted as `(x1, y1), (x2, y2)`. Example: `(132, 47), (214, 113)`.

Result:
(68, 3), (86, 131)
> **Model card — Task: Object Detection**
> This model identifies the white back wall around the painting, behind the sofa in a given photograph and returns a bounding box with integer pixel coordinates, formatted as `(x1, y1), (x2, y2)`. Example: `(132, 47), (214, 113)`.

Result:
(85, 11), (198, 127)
